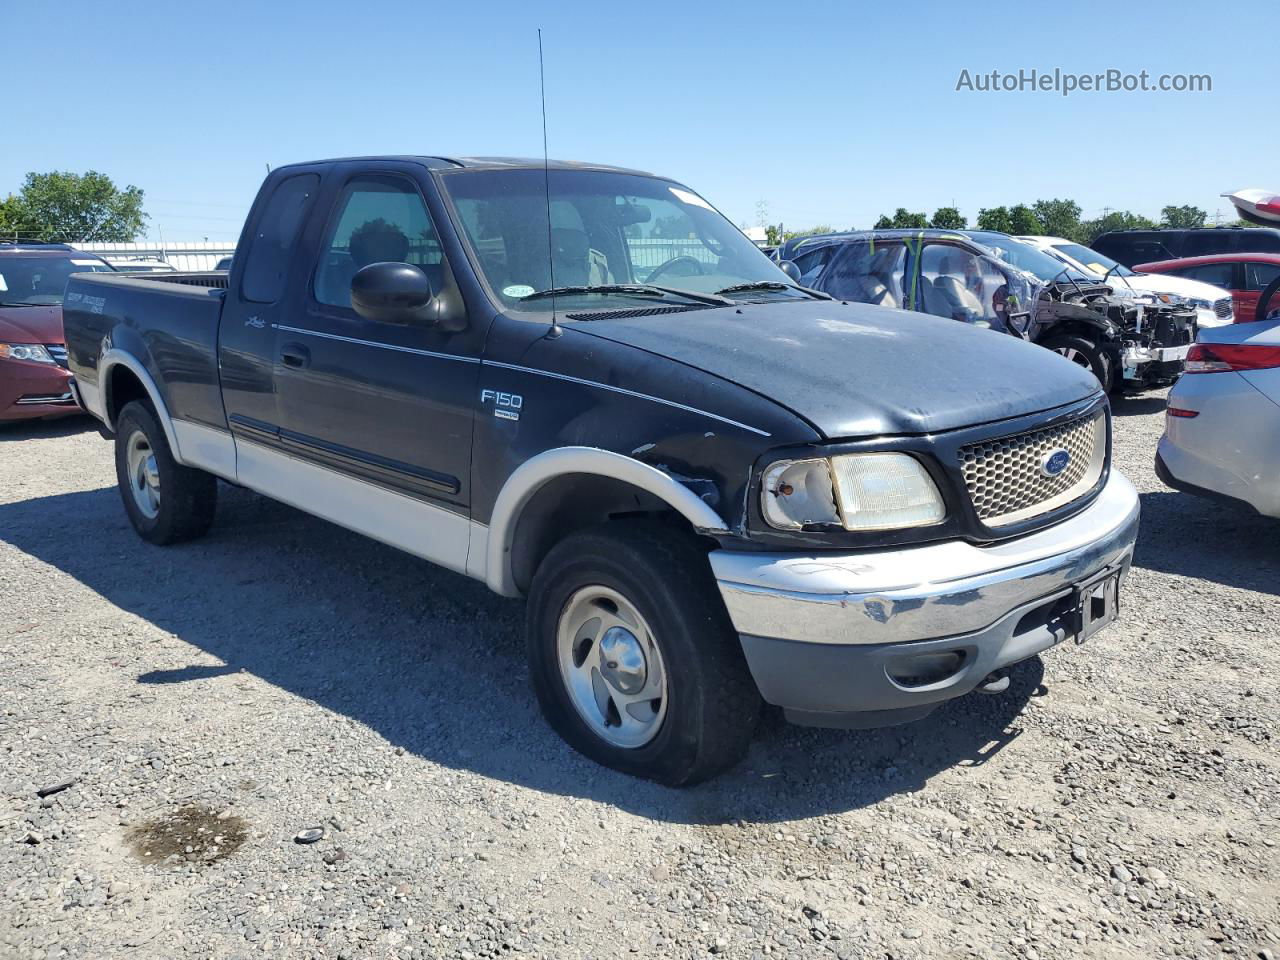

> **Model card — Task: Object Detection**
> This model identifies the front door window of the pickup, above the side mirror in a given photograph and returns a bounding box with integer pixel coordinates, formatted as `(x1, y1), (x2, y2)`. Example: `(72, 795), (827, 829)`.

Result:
(315, 175), (443, 310)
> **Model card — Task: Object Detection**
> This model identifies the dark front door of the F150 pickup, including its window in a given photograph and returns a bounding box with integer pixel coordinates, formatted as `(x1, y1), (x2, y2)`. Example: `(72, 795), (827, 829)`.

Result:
(274, 163), (480, 513)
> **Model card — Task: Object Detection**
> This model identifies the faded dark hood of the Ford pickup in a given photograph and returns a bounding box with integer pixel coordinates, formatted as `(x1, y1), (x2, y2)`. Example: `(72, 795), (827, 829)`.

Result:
(572, 301), (1100, 439)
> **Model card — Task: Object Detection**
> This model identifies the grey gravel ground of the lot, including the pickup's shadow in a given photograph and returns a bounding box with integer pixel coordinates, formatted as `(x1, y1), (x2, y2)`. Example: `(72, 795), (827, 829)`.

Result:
(0, 397), (1280, 960)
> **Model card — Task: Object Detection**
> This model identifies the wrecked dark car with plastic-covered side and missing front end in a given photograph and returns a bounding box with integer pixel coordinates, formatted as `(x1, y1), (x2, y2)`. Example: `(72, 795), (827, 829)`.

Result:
(778, 229), (1197, 392)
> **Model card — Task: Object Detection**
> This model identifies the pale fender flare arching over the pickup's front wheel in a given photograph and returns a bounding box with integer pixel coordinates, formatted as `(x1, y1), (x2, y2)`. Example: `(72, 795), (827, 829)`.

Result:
(485, 447), (727, 596)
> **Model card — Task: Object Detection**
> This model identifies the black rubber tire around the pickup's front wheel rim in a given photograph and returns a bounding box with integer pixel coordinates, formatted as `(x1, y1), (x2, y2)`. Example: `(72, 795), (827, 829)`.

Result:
(526, 521), (762, 786)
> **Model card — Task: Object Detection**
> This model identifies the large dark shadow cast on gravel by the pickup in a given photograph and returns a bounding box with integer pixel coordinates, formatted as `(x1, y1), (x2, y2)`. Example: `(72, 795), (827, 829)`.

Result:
(0, 485), (1046, 823)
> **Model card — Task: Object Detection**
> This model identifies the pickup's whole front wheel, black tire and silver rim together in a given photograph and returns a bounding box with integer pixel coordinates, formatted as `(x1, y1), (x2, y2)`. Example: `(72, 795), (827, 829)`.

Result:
(527, 521), (760, 786)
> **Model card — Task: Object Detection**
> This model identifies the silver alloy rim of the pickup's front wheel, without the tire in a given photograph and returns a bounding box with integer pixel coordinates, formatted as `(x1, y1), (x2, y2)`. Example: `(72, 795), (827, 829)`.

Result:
(556, 586), (667, 750)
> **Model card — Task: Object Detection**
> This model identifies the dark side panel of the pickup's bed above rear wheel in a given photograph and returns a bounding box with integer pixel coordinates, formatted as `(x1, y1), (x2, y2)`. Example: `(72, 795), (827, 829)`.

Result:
(63, 271), (228, 429)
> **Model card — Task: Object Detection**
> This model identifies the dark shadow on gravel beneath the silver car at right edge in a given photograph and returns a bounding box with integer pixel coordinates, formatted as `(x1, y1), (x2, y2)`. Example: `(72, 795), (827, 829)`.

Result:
(1134, 490), (1280, 596)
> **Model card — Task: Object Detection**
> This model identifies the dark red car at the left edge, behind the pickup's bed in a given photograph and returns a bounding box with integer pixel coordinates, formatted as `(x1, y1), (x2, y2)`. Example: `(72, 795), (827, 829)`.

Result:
(0, 243), (111, 421)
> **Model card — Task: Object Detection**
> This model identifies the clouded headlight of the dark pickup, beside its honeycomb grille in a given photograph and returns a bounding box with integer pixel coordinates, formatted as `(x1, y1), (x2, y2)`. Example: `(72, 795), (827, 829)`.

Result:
(760, 453), (947, 530)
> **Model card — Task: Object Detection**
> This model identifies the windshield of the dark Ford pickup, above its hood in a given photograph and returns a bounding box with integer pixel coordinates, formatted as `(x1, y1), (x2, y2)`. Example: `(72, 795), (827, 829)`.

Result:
(440, 169), (806, 311)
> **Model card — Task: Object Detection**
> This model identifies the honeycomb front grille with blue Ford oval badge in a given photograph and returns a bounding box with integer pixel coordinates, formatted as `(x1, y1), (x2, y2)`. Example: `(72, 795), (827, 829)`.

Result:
(957, 412), (1107, 527)
